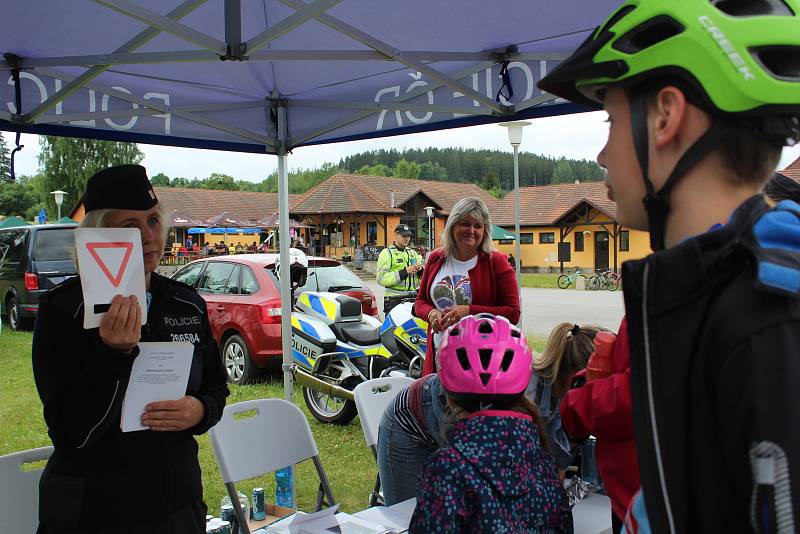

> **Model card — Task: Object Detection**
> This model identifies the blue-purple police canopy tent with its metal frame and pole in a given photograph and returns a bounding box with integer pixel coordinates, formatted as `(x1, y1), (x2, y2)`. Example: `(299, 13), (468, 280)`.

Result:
(0, 0), (620, 406)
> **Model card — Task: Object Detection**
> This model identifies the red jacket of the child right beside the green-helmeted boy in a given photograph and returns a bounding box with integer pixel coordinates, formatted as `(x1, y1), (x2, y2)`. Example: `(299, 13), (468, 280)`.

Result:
(559, 318), (641, 520)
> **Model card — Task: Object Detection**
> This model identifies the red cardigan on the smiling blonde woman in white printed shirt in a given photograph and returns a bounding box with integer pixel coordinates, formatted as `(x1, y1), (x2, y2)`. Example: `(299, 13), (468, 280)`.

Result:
(414, 249), (519, 376)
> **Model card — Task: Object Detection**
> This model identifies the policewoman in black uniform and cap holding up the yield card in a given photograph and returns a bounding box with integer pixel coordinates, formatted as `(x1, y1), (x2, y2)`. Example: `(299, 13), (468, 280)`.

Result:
(33, 165), (228, 534)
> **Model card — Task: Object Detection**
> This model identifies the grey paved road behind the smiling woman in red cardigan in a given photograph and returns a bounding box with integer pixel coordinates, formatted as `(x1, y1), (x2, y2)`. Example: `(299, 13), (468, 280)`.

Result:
(364, 280), (625, 336)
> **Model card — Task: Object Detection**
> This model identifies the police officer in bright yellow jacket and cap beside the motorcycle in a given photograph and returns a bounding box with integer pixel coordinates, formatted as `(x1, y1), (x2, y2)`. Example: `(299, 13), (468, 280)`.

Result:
(377, 224), (422, 313)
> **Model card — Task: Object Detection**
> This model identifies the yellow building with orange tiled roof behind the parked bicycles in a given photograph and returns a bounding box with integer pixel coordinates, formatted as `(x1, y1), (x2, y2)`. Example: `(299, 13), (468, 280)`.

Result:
(492, 182), (651, 271)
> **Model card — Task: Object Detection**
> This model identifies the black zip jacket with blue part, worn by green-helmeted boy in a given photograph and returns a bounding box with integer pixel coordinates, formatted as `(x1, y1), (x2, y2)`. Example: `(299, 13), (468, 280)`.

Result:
(623, 196), (800, 533)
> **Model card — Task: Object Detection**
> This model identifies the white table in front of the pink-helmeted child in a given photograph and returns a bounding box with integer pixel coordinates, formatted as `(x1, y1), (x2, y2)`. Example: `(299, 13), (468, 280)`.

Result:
(253, 493), (611, 534)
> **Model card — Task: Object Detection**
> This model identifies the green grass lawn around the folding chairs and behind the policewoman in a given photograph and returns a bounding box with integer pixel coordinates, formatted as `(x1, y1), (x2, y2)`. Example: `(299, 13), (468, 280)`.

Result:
(0, 328), (544, 515)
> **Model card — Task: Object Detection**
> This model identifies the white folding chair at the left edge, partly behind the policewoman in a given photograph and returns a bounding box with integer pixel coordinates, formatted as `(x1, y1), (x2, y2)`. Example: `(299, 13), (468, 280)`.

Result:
(0, 447), (53, 532)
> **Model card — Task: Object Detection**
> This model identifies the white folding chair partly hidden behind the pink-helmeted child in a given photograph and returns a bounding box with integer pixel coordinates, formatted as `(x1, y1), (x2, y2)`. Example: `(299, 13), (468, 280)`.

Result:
(353, 376), (414, 506)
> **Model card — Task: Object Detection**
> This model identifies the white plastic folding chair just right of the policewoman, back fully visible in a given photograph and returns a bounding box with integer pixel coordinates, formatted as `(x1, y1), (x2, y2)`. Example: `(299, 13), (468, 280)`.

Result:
(209, 399), (335, 534)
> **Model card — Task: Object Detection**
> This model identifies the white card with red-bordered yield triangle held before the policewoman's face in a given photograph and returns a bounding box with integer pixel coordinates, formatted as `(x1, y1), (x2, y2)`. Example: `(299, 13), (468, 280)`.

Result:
(75, 228), (147, 328)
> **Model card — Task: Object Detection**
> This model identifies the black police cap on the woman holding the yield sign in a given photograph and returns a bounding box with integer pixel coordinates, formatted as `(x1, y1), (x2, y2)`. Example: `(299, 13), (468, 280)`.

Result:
(83, 165), (158, 213)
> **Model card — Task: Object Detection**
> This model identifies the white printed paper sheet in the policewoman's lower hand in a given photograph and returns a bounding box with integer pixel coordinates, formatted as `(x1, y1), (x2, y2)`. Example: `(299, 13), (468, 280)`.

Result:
(120, 342), (194, 432)
